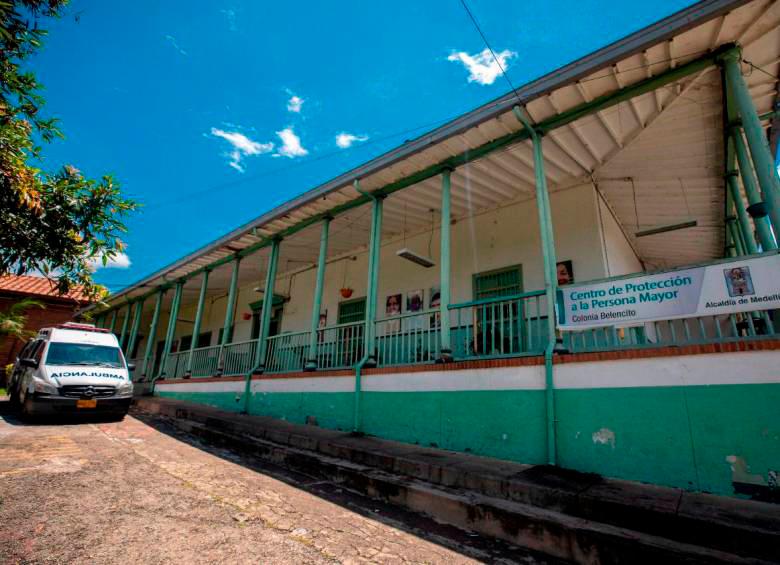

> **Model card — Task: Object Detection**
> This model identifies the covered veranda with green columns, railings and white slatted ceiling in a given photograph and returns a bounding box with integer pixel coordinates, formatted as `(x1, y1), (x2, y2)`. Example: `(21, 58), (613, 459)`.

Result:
(93, 0), (780, 390)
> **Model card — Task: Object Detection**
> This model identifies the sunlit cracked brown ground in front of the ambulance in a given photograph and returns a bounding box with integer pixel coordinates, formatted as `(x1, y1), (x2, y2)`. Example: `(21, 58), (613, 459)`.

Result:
(0, 400), (538, 564)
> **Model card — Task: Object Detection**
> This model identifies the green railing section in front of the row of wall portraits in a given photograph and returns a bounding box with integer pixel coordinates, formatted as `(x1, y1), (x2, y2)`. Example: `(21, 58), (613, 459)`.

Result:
(376, 310), (441, 367)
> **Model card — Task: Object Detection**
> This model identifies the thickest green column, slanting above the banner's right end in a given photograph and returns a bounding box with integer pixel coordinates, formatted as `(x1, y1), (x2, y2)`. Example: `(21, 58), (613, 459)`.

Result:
(721, 50), (780, 239)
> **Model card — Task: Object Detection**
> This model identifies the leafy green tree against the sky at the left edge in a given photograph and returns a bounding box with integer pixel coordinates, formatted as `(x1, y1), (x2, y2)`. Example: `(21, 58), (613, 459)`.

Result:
(0, 0), (137, 300)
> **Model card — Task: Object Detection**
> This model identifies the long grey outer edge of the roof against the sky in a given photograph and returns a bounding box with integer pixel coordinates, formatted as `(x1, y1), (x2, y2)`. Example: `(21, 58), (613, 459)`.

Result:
(90, 0), (752, 311)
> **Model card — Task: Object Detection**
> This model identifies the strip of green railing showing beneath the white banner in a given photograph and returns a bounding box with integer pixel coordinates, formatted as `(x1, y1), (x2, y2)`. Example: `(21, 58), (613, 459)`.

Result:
(562, 310), (780, 353)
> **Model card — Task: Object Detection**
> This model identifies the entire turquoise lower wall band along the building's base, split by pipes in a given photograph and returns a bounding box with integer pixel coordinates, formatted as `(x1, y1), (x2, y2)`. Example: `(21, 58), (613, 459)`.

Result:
(160, 384), (780, 495)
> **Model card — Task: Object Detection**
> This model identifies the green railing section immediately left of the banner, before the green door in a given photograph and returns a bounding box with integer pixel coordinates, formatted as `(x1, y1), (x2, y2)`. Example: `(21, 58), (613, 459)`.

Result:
(449, 290), (547, 359)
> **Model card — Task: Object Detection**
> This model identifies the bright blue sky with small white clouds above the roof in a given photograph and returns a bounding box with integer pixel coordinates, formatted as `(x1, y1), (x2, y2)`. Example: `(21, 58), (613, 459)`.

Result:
(29, 0), (691, 292)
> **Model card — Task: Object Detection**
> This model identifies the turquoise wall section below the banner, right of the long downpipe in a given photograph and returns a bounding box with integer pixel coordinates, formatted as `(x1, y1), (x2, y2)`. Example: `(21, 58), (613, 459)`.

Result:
(557, 384), (780, 494)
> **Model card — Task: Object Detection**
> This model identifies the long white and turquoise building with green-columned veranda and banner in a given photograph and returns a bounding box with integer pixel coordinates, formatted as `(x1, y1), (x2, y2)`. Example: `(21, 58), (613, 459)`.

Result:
(89, 0), (780, 497)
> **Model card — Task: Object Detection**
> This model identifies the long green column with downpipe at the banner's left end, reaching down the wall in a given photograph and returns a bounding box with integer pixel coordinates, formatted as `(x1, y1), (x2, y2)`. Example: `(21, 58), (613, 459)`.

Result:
(513, 106), (558, 465)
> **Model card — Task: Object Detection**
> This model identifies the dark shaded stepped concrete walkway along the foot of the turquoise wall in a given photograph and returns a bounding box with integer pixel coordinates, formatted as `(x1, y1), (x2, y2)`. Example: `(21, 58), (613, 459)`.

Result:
(138, 397), (780, 563)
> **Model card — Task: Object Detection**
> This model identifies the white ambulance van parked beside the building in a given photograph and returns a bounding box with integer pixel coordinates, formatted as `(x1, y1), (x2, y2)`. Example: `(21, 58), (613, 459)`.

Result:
(9, 322), (133, 420)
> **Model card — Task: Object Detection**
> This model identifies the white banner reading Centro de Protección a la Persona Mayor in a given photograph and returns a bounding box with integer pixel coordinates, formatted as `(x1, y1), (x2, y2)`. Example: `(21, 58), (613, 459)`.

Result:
(558, 253), (780, 330)
